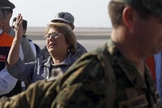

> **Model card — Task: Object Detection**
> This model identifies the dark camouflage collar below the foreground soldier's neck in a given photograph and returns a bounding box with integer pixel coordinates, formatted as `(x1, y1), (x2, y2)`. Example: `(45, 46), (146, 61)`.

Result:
(107, 39), (151, 89)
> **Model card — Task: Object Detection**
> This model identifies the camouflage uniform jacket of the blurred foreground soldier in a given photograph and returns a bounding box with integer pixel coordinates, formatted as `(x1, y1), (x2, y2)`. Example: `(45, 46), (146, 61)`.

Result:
(0, 39), (162, 108)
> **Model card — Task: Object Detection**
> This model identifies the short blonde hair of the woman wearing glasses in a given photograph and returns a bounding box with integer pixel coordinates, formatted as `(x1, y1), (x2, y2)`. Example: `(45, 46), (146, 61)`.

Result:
(46, 22), (77, 54)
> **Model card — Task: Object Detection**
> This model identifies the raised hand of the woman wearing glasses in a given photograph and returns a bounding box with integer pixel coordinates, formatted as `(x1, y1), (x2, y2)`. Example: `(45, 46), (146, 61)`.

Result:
(14, 14), (24, 38)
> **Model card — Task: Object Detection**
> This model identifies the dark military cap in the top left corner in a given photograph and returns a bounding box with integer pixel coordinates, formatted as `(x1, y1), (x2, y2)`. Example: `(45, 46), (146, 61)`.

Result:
(0, 0), (15, 9)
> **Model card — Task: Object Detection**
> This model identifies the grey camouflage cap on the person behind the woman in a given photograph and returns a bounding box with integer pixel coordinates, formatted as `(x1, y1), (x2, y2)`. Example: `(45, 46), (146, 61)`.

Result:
(51, 12), (74, 24)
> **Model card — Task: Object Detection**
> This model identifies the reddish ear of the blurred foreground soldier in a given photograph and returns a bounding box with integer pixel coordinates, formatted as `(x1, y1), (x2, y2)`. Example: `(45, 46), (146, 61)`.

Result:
(122, 6), (136, 29)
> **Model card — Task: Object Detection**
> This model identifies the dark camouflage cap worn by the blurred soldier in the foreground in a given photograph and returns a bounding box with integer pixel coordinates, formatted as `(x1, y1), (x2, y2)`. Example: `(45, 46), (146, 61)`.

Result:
(111, 0), (162, 17)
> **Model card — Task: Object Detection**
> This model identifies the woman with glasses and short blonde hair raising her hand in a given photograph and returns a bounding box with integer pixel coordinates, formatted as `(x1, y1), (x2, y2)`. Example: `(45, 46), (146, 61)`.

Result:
(7, 14), (76, 83)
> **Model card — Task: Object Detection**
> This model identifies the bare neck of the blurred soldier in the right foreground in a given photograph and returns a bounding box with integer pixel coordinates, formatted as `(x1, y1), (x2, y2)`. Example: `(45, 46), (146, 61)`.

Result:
(111, 28), (145, 78)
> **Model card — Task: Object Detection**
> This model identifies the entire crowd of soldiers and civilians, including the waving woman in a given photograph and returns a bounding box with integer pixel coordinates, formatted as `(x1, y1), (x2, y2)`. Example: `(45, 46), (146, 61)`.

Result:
(0, 0), (162, 108)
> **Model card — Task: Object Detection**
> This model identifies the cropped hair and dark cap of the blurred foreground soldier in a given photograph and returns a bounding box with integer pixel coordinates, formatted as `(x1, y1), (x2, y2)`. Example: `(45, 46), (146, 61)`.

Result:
(109, 0), (162, 28)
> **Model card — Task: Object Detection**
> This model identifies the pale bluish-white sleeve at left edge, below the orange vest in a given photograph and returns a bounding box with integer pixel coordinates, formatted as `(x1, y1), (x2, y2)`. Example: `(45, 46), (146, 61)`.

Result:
(0, 68), (17, 95)
